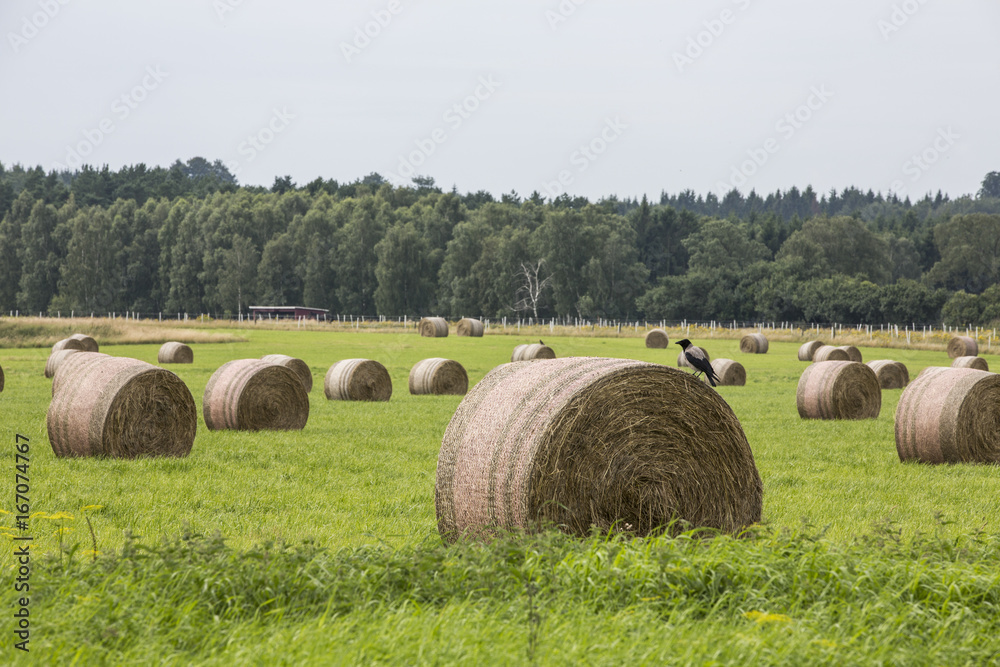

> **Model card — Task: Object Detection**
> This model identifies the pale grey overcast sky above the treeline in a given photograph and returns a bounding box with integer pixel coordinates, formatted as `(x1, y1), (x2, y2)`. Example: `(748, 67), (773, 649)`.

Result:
(0, 0), (1000, 199)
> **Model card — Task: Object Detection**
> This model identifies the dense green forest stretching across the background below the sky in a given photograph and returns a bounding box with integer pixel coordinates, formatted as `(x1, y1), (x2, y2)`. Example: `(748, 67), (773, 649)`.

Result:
(0, 158), (1000, 325)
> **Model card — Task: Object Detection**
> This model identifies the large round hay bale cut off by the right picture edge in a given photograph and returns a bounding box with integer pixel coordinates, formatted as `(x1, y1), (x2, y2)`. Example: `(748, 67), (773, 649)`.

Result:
(896, 367), (1000, 463)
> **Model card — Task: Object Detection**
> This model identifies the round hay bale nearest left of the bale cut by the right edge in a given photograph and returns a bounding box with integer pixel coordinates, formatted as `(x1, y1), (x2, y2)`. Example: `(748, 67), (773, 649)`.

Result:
(795, 361), (882, 419)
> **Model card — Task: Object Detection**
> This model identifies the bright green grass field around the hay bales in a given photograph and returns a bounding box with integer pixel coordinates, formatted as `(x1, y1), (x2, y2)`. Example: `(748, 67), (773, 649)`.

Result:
(0, 328), (1000, 664)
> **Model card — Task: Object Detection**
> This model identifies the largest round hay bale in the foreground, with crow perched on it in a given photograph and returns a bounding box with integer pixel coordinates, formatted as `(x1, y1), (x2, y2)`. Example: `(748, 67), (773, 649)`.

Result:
(435, 357), (763, 541)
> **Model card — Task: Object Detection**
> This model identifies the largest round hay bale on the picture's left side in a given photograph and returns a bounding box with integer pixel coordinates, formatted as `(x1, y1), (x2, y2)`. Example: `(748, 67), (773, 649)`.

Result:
(46, 352), (198, 459)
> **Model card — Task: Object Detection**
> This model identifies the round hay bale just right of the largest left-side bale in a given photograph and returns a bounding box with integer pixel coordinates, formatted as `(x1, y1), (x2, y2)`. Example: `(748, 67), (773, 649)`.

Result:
(202, 359), (309, 431)
